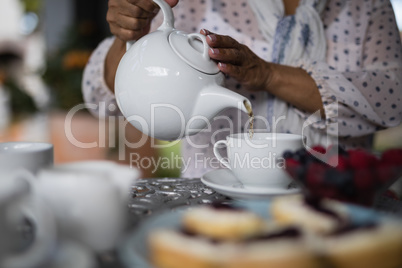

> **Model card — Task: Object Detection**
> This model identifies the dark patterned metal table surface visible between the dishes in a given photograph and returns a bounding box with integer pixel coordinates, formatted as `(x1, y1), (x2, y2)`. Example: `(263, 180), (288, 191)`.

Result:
(98, 178), (402, 268)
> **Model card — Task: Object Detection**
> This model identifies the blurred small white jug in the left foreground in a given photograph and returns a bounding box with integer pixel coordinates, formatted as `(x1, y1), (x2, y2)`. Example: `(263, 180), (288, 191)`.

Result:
(38, 161), (139, 252)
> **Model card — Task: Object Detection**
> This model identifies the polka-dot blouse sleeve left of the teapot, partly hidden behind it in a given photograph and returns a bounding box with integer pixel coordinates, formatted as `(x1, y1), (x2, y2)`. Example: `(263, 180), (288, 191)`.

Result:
(82, 37), (120, 118)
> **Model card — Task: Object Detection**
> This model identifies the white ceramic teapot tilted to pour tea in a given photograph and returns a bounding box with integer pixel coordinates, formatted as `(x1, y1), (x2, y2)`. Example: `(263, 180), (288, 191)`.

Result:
(115, 0), (251, 140)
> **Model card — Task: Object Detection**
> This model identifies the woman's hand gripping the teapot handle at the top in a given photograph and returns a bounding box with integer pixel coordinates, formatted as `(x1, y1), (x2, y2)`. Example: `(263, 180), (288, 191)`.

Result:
(106, 0), (178, 42)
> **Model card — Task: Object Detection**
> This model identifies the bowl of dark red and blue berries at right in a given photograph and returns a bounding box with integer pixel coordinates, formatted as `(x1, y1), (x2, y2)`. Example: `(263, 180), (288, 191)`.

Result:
(283, 146), (402, 206)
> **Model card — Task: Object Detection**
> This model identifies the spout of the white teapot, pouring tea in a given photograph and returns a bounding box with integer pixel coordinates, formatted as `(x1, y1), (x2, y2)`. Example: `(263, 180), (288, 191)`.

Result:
(193, 85), (251, 119)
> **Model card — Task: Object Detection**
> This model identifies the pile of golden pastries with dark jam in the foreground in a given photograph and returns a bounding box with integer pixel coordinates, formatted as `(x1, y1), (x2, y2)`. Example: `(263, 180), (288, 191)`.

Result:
(148, 202), (402, 268)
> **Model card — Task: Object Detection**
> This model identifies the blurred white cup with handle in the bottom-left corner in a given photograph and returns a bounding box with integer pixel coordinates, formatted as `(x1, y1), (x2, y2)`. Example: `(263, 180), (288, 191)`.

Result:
(0, 168), (57, 268)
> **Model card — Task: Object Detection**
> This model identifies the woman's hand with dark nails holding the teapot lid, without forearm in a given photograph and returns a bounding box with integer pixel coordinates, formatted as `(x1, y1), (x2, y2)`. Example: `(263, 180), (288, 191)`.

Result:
(201, 29), (272, 91)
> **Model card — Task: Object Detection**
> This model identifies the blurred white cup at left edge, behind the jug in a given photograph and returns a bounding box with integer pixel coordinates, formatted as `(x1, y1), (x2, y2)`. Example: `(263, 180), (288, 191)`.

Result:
(0, 141), (53, 174)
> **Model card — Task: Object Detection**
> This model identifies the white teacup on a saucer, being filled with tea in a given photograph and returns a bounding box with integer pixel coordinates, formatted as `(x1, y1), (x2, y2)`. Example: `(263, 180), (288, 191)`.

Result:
(214, 133), (303, 189)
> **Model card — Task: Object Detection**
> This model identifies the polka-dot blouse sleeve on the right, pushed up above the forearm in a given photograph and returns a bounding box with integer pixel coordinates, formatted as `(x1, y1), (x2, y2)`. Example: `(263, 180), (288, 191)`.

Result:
(297, 1), (402, 137)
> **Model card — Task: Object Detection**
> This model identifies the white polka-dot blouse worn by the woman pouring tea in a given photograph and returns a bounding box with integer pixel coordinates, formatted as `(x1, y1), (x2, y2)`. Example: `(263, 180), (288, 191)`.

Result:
(83, 0), (402, 176)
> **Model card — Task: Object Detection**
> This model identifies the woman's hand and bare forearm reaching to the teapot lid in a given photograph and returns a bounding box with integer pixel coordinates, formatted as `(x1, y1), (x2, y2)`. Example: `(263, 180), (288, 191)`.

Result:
(201, 29), (325, 117)
